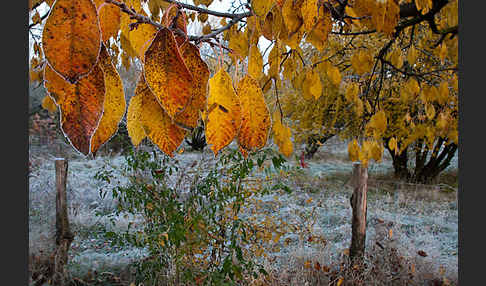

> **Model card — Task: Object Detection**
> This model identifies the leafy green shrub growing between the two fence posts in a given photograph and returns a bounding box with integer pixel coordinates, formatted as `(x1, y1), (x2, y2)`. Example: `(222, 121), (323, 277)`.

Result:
(96, 146), (290, 285)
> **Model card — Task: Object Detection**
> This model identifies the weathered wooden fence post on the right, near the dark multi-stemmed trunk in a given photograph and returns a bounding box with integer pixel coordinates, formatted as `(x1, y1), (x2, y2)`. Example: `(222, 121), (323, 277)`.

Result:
(349, 163), (368, 262)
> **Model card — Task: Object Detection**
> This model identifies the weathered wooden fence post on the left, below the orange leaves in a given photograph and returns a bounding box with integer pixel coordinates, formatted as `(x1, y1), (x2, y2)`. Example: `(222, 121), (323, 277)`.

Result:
(53, 158), (74, 285)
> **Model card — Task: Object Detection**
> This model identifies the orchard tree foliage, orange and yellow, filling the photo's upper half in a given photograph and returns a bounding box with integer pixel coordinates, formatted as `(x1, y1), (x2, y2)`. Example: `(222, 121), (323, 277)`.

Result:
(29, 0), (458, 181)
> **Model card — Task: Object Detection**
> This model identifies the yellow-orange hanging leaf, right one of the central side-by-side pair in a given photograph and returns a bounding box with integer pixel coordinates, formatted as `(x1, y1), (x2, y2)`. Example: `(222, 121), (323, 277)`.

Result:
(236, 75), (271, 151)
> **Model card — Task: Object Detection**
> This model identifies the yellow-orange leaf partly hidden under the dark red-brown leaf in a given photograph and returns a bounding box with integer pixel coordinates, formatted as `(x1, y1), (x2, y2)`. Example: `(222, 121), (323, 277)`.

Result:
(135, 75), (185, 157)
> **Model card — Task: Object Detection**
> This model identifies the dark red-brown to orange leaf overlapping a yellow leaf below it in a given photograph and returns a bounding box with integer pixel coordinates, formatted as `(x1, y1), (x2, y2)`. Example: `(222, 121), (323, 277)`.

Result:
(144, 28), (193, 118)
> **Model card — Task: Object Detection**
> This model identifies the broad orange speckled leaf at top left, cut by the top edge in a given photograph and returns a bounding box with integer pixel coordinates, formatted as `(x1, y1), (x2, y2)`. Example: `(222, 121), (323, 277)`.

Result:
(42, 0), (101, 83)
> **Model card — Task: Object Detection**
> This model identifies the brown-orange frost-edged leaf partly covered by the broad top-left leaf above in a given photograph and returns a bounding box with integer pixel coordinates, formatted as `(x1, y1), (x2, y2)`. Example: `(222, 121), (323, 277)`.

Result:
(44, 65), (105, 155)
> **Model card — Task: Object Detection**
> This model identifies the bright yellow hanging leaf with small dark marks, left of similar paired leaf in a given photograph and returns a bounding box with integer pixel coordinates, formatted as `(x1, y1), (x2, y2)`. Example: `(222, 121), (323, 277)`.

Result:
(205, 68), (241, 155)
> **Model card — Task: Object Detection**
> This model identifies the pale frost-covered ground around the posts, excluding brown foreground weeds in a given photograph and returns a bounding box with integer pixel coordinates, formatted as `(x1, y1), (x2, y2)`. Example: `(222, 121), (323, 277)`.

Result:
(29, 138), (458, 284)
